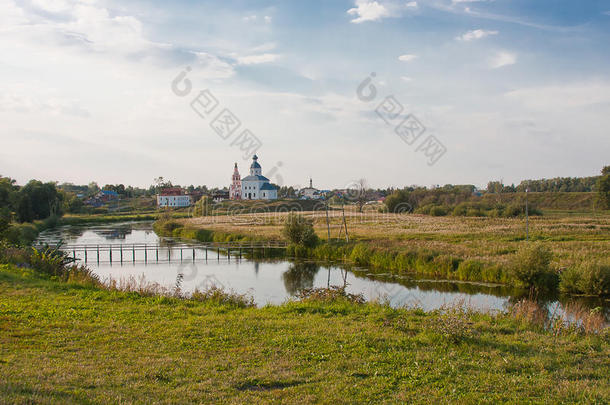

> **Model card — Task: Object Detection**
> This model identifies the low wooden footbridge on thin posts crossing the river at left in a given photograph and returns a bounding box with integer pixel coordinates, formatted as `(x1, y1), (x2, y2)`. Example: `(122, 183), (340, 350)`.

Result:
(38, 241), (288, 263)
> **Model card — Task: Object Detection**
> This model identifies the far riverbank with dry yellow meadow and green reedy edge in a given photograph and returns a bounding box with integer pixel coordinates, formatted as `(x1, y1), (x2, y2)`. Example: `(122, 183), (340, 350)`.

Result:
(159, 210), (610, 296)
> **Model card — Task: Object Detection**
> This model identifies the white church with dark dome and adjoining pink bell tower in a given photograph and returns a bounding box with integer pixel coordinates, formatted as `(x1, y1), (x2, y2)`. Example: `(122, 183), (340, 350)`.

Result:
(229, 155), (277, 200)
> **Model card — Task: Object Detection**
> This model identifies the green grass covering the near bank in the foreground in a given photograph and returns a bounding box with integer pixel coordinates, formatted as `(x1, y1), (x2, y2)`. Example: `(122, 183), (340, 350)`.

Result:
(0, 265), (610, 404)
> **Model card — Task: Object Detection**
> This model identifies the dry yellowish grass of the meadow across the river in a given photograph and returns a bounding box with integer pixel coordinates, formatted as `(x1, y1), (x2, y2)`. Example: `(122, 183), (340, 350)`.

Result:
(180, 207), (610, 268)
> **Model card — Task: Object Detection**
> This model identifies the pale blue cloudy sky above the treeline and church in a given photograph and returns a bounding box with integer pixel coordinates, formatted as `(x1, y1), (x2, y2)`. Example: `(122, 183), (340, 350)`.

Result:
(0, 0), (610, 189)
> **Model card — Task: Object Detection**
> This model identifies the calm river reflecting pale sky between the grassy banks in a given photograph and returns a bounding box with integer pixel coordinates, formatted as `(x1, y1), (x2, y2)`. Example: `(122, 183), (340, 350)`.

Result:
(38, 222), (610, 319)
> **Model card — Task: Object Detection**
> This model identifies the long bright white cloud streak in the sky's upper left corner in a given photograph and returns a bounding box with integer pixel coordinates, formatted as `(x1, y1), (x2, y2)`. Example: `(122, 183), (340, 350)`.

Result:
(0, 0), (234, 79)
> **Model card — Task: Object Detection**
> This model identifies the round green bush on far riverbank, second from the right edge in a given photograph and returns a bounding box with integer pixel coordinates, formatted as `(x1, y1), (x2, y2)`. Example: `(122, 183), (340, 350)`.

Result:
(511, 243), (559, 290)
